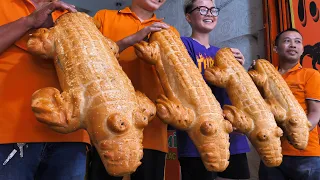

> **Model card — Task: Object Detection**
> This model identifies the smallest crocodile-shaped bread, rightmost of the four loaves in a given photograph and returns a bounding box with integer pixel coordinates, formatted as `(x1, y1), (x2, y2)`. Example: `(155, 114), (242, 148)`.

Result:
(249, 59), (311, 150)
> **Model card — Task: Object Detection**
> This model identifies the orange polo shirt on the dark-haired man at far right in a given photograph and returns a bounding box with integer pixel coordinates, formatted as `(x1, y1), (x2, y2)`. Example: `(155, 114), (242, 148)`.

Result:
(281, 63), (320, 156)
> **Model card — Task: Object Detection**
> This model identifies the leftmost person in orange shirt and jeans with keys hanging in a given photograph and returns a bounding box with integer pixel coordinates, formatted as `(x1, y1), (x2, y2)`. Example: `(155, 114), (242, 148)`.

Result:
(0, 0), (90, 180)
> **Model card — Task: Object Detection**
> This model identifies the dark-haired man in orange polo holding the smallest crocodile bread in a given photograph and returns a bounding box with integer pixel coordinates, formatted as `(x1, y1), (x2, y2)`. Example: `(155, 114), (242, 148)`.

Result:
(259, 29), (320, 180)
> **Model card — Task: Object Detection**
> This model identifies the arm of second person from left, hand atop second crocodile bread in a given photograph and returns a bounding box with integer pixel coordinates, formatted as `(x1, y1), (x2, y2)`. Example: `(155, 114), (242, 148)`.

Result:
(116, 22), (170, 52)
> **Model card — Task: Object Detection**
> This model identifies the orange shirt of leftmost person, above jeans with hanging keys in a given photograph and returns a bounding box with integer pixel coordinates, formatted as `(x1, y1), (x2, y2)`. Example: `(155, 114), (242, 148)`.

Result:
(0, 0), (90, 144)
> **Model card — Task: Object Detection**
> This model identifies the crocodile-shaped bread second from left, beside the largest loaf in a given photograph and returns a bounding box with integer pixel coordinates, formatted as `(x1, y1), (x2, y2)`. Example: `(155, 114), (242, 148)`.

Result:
(135, 29), (232, 172)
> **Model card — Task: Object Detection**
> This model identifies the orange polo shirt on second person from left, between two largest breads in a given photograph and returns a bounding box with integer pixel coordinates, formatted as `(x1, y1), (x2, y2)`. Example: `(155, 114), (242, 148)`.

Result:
(95, 7), (179, 152)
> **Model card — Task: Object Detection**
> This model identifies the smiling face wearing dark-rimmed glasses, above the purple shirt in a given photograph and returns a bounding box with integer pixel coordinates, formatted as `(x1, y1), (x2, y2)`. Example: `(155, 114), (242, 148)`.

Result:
(186, 0), (218, 33)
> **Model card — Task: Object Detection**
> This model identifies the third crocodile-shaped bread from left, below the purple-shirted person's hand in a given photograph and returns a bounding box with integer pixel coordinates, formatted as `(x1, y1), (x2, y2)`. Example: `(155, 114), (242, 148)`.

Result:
(204, 48), (283, 167)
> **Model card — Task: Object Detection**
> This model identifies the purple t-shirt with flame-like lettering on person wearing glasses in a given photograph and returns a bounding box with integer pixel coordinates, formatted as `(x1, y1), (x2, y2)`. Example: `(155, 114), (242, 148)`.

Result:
(177, 37), (250, 157)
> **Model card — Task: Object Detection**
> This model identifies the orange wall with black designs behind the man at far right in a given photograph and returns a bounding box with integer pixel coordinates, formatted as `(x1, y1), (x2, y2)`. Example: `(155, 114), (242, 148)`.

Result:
(263, 0), (320, 144)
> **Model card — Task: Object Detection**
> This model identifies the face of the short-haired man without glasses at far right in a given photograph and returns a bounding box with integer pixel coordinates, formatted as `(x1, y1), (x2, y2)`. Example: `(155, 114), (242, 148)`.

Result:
(275, 31), (303, 63)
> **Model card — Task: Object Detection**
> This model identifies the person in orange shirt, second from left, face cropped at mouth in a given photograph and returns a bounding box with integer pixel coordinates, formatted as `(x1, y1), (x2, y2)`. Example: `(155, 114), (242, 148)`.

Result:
(89, 0), (177, 180)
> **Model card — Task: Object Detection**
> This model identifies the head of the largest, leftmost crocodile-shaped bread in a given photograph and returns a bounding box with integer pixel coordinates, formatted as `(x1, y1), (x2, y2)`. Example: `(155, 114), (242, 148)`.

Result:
(91, 113), (148, 176)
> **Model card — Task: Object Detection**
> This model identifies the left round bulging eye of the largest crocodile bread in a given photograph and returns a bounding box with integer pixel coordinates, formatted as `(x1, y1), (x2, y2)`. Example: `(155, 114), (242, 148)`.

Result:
(107, 114), (130, 133)
